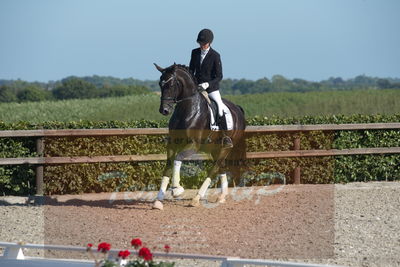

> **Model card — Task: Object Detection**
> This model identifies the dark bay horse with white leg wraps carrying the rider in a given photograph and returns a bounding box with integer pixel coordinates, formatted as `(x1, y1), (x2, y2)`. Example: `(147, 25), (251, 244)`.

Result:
(153, 64), (246, 209)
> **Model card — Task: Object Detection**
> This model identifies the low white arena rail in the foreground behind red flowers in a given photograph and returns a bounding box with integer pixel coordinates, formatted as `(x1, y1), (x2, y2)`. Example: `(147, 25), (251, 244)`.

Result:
(0, 242), (344, 267)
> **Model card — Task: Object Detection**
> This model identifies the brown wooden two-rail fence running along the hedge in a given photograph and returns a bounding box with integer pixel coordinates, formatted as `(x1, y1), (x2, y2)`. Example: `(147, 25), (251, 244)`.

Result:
(0, 123), (400, 195)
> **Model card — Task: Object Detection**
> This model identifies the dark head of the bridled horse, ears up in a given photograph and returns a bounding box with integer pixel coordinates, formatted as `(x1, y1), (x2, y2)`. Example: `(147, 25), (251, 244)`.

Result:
(154, 63), (181, 116)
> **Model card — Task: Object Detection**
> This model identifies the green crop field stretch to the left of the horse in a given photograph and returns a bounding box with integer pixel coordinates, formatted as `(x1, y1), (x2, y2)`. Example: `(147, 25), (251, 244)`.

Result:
(0, 94), (166, 123)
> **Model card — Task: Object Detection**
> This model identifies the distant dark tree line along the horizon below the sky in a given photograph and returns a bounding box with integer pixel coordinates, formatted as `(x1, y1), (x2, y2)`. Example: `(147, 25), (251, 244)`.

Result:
(0, 75), (400, 103)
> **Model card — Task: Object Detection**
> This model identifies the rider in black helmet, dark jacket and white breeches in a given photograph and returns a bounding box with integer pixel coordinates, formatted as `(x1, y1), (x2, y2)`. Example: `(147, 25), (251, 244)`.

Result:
(189, 29), (233, 148)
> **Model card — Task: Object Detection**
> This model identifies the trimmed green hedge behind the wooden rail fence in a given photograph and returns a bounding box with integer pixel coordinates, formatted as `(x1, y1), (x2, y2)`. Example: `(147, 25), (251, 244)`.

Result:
(0, 114), (400, 195)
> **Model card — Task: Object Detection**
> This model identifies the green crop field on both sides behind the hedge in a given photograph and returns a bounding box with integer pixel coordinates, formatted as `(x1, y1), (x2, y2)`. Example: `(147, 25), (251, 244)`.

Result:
(0, 89), (400, 123)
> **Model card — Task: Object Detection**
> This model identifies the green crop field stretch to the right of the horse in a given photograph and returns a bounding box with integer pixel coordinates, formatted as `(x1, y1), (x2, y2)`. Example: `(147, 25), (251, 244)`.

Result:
(225, 90), (400, 117)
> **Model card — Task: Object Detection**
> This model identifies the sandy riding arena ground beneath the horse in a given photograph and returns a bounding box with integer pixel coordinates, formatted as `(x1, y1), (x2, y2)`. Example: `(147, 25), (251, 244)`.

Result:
(0, 182), (400, 266)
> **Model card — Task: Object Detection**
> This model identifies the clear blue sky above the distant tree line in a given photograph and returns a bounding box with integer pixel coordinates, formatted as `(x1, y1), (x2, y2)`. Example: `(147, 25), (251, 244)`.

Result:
(0, 0), (400, 82)
